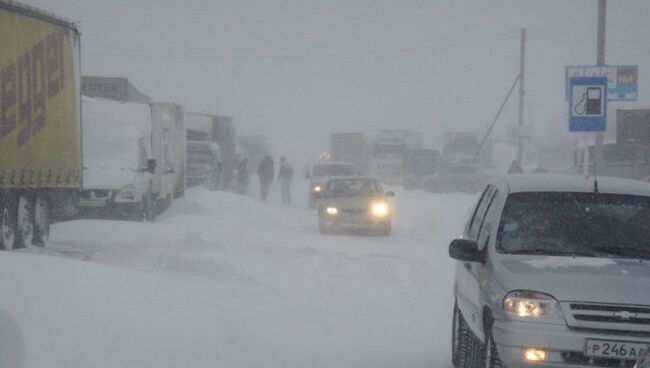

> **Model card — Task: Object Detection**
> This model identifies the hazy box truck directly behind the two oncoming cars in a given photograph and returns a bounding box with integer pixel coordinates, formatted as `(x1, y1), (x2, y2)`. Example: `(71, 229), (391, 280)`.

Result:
(329, 132), (370, 174)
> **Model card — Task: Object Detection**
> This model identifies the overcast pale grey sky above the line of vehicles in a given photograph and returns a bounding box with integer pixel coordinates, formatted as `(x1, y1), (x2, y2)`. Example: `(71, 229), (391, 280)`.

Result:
(26, 0), (650, 159)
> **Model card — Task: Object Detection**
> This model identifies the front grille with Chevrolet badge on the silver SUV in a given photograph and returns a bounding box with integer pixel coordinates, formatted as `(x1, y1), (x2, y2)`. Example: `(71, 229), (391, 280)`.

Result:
(564, 303), (650, 333)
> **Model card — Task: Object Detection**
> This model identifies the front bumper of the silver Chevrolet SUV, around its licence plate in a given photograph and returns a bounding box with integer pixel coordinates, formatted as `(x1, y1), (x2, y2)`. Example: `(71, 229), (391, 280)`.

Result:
(492, 320), (650, 368)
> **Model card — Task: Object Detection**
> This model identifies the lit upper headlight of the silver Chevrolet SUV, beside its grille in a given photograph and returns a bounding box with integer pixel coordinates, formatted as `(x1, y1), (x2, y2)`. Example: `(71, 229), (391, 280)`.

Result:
(503, 290), (564, 320)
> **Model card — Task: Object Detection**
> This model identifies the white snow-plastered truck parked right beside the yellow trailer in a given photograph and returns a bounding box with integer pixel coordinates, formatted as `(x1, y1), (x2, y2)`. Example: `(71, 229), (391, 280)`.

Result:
(78, 97), (177, 221)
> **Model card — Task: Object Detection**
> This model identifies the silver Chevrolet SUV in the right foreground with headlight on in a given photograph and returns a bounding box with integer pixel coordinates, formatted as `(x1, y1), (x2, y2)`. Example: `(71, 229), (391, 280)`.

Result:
(449, 174), (650, 367)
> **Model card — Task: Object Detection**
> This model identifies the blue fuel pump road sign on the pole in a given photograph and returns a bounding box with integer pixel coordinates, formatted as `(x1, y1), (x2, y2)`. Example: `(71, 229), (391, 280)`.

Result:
(569, 77), (607, 132)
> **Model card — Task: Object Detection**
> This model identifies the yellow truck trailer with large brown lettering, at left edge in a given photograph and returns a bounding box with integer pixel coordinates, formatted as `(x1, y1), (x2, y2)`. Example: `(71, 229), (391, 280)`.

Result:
(0, 0), (82, 249)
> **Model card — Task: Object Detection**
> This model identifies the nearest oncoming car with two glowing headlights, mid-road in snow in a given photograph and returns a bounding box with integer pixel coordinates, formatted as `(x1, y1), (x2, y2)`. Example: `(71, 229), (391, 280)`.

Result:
(318, 176), (394, 236)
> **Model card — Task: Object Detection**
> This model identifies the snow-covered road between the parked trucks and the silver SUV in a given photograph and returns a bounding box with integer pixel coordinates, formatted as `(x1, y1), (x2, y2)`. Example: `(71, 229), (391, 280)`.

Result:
(0, 184), (476, 368)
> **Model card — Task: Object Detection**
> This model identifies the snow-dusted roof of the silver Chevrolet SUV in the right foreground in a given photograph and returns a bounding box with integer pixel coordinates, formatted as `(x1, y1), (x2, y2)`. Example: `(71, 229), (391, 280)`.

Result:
(493, 174), (650, 196)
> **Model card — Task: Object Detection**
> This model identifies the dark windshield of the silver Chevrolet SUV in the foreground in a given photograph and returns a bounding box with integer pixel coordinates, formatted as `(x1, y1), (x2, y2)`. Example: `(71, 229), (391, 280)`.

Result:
(497, 192), (650, 259)
